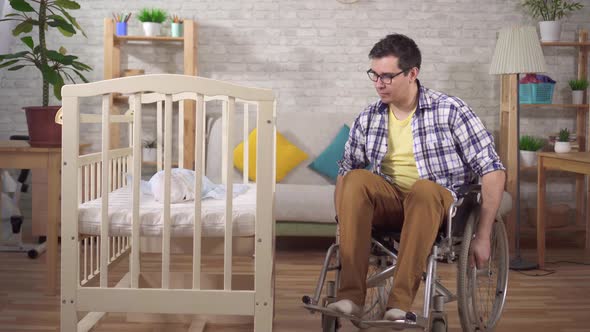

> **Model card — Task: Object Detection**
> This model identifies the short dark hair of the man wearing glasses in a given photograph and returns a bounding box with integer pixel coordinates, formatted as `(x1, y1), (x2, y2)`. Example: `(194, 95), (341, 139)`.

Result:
(369, 33), (422, 71)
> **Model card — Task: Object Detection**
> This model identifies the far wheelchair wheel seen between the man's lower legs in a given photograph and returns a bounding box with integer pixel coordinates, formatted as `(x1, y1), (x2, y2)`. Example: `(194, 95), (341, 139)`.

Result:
(353, 256), (395, 328)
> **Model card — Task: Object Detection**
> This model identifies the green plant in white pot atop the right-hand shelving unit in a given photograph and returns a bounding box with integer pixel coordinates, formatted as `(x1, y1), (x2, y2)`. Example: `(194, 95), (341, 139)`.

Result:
(523, 0), (583, 42)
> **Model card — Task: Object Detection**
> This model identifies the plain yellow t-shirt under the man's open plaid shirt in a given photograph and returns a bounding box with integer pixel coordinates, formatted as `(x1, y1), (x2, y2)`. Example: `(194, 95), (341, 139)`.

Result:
(381, 105), (418, 192)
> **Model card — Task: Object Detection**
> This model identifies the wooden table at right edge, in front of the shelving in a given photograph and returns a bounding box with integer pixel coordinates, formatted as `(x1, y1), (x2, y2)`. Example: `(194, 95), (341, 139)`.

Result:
(537, 152), (590, 268)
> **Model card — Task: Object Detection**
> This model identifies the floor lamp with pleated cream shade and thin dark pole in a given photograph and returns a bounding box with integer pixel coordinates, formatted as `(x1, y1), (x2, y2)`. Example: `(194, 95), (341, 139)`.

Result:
(490, 26), (547, 270)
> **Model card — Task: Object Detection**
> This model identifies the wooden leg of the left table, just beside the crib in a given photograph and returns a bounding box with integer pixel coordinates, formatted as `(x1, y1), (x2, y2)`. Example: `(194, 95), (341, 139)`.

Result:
(46, 153), (61, 295)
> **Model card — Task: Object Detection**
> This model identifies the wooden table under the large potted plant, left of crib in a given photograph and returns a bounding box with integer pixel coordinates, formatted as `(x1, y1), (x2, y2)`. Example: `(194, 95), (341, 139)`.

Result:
(0, 141), (61, 295)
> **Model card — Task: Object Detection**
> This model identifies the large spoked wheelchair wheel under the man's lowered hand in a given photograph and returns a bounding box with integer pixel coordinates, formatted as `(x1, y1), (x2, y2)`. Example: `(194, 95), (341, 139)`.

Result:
(457, 208), (509, 332)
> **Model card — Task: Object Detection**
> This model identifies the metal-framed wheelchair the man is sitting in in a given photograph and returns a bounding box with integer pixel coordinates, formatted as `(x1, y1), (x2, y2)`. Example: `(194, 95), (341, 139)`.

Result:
(302, 185), (510, 332)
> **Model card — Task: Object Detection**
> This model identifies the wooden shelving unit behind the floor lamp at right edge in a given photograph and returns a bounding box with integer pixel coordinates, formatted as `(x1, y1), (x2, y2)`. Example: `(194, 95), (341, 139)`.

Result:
(499, 30), (590, 248)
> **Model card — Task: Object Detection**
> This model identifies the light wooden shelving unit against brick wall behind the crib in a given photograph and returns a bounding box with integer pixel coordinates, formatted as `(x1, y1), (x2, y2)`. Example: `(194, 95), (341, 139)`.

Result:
(104, 18), (197, 167)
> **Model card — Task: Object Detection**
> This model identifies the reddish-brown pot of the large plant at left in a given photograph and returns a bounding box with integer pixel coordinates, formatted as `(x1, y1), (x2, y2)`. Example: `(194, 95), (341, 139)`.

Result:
(23, 106), (61, 147)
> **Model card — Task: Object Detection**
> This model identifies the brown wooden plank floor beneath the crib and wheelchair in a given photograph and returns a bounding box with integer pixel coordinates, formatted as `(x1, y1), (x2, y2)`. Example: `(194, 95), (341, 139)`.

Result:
(0, 239), (590, 332)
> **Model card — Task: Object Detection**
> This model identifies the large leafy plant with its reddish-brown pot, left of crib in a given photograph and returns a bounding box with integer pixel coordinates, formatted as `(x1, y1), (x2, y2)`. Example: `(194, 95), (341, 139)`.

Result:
(0, 0), (92, 146)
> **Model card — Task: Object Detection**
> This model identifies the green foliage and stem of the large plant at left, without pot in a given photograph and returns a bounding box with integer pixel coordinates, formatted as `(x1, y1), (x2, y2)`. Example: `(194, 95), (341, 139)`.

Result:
(0, 0), (92, 107)
